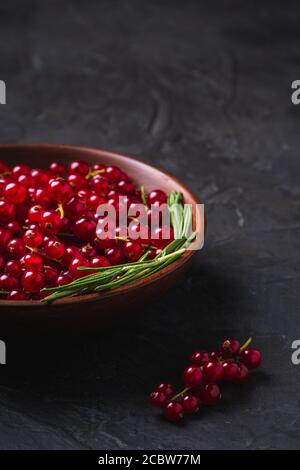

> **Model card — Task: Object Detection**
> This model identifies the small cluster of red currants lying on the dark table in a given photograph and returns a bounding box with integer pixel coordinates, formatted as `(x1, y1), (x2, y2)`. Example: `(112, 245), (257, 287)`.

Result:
(150, 338), (261, 422)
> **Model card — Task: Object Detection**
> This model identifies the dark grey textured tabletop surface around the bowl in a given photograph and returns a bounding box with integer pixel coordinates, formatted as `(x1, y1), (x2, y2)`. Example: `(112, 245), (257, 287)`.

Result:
(0, 0), (300, 449)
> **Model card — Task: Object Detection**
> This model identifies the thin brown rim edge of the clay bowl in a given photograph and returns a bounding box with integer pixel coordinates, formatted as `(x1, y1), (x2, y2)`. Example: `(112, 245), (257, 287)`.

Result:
(0, 142), (200, 308)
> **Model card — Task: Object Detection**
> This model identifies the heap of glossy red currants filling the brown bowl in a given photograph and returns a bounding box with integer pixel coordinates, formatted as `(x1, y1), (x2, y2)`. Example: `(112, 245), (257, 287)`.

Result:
(0, 161), (173, 300)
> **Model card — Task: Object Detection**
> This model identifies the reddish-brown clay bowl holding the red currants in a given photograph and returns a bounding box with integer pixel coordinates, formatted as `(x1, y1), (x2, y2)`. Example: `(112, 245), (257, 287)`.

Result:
(0, 144), (199, 331)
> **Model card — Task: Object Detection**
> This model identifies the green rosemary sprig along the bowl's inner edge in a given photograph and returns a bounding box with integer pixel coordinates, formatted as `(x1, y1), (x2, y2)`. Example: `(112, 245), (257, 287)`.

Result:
(42, 192), (196, 302)
